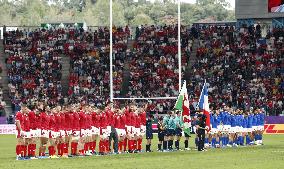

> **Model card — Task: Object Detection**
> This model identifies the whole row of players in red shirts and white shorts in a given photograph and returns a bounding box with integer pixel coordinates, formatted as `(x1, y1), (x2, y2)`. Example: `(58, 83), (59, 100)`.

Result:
(16, 105), (146, 157)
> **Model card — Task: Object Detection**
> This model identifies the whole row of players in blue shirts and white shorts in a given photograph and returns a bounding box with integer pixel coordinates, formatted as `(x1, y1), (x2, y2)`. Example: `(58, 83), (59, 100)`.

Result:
(200, 106), (265, 148)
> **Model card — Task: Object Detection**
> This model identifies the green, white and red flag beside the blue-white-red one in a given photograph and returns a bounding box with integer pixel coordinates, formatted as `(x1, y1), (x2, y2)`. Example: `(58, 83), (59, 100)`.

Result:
(175, 81), (191, 135)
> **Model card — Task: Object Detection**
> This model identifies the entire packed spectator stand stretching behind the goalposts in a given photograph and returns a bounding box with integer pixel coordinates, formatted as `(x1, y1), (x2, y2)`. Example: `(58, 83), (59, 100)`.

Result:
(0, 25), (284, 115)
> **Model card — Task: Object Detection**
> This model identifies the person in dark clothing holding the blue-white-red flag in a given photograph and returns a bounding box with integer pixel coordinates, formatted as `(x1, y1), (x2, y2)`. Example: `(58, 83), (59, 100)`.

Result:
(195, 113), (206, 151)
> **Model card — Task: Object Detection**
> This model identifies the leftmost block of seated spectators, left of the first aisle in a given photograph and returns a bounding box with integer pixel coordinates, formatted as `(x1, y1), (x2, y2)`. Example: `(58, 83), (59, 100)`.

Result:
(4, 29), (64, 111)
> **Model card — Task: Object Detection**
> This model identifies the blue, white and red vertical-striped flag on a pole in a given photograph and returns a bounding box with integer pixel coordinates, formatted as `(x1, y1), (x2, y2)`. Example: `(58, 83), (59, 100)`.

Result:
(198, 81), (211, 130)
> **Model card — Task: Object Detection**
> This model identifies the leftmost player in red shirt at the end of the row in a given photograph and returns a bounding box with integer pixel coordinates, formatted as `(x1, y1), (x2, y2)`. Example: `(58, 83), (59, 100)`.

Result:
(15, 105), (27, 160)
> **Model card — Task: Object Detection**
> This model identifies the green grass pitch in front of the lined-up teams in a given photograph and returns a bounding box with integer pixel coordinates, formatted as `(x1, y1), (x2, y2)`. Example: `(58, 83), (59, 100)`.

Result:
(0, 135), (284, 169)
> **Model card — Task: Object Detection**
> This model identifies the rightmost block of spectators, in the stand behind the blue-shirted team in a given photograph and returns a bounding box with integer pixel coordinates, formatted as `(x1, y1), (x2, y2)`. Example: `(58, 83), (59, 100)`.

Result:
(188, 25), (284, 115)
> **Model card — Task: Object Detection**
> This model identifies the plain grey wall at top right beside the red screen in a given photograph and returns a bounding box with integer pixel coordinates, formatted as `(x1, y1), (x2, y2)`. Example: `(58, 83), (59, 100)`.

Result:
(235, 0), (284, 19)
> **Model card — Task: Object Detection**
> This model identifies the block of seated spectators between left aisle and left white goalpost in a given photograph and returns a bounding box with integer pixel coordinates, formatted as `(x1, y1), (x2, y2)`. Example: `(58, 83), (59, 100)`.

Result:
(65, 27), (110, 107)
